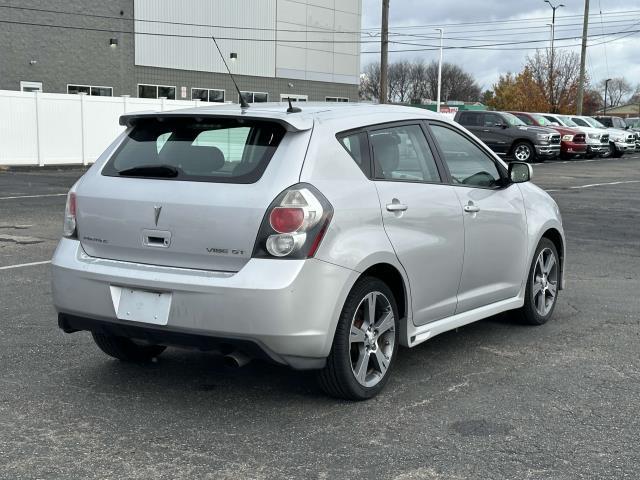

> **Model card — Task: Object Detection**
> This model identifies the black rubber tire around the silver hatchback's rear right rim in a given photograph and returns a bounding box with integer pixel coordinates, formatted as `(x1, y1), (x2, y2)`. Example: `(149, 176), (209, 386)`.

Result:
(318, 277), (399, 400)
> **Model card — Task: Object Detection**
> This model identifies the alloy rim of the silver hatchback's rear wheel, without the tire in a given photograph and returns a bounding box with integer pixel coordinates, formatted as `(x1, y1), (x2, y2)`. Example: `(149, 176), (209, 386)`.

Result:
(349, 292), (396, 387)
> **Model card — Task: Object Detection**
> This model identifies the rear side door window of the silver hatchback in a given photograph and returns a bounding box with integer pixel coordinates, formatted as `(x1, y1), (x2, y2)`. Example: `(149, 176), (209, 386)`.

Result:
(370, 125), (440, 182)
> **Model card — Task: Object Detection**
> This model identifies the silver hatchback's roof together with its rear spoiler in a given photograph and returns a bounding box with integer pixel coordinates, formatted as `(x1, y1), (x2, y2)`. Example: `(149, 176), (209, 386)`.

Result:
(120, 102), (451, 131)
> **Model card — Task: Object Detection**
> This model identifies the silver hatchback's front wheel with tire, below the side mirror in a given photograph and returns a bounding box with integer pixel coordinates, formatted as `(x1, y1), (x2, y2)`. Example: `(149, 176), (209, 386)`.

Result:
(516, 238), (561, 325)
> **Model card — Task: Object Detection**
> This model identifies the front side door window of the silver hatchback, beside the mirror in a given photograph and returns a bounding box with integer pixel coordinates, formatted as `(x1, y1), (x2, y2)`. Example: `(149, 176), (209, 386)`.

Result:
(431, 125), (500, 188)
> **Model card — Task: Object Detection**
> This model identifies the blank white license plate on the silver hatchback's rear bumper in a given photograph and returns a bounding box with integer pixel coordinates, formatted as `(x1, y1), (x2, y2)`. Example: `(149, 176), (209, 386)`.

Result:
(111, 285), (171, 325)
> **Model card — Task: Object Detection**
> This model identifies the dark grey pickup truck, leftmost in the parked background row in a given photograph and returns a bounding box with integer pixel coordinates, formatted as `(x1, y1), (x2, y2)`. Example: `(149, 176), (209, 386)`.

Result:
(455, 111), (560, 162)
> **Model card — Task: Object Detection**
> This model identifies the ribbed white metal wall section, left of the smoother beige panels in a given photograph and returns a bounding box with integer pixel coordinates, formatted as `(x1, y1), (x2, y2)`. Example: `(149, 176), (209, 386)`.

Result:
(134, 0), (276, 77)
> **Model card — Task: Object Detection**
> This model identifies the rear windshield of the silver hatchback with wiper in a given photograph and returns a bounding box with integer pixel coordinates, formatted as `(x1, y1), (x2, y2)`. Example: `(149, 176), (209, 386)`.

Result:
(102, 118), (285, 183)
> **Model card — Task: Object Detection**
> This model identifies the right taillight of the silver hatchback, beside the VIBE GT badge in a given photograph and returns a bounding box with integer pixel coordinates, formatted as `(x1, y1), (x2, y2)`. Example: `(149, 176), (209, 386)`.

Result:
(252, 183), (333, 259)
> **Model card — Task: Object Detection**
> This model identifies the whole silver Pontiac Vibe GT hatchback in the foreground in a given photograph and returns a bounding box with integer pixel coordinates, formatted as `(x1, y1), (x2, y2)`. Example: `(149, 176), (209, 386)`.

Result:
(53, 104), (565, 399)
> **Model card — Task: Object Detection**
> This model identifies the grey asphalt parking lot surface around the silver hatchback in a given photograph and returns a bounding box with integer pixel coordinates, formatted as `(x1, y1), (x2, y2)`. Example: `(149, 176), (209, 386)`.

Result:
(0, 155), (640, 479)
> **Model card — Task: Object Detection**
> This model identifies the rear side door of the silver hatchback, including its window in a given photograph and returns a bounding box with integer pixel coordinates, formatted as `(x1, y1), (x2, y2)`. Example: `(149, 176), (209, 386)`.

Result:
(369, 122), (464, 325)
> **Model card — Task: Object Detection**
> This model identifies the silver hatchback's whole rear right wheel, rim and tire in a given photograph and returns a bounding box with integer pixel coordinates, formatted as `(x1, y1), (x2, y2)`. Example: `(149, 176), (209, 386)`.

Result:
(319, 277), (399, 400)
